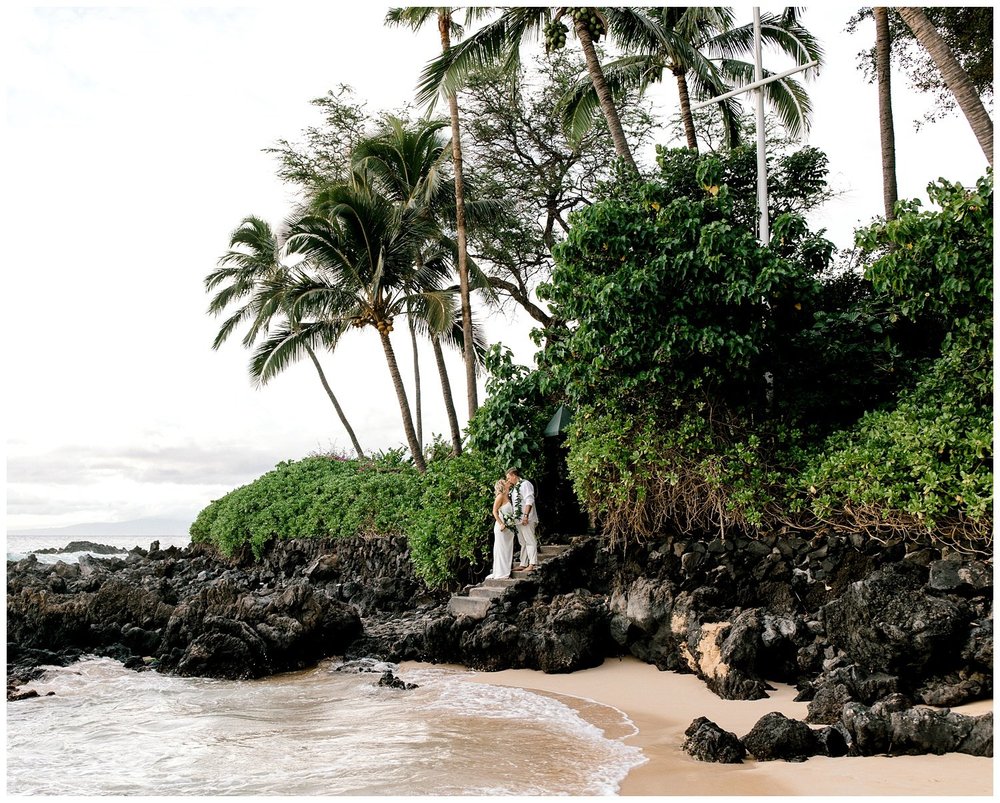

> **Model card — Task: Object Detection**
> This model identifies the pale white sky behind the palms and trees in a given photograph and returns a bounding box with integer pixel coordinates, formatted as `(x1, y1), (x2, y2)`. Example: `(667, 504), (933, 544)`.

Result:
(0, 3), (986, 530)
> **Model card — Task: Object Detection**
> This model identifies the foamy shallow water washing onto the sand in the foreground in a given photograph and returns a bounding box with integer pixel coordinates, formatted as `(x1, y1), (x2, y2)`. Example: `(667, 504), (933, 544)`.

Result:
(7, 658), (645, 796)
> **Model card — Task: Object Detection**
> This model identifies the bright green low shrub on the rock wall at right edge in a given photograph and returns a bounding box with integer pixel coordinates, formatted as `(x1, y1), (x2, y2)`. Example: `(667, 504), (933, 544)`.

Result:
(799, 326), (993, 545)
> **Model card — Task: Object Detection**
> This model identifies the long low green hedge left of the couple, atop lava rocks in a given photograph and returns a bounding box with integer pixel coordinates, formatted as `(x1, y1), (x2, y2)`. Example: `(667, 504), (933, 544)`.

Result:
(191, 449), (502, 588)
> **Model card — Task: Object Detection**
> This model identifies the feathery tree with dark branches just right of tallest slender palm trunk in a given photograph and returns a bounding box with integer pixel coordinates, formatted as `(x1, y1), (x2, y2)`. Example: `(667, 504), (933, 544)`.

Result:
(462, 49), (654, 328)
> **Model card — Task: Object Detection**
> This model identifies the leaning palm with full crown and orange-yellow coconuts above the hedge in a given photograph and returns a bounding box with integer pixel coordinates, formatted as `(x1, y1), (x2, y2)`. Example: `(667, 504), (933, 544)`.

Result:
(289, 181), (452, 471)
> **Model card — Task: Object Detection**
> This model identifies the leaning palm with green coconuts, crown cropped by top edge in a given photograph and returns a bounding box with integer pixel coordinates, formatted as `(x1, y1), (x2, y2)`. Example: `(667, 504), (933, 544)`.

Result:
(417, 7), (638, 171)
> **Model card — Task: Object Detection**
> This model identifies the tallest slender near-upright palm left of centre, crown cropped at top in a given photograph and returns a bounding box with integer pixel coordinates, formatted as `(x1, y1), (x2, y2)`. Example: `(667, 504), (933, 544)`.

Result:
(386, 6), (479, 419)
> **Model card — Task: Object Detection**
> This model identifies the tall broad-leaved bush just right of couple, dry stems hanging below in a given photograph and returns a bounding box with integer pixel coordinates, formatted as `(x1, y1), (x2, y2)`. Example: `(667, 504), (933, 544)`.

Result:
(542, 151), (832, 537)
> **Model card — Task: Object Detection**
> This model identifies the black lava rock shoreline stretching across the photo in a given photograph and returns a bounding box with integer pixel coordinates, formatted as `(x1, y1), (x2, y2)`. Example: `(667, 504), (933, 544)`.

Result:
(7, 535), (993, 761)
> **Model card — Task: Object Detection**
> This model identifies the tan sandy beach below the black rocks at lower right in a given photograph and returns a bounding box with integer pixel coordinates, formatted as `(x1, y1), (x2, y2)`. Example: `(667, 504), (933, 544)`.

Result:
(404, 658), (993, 796)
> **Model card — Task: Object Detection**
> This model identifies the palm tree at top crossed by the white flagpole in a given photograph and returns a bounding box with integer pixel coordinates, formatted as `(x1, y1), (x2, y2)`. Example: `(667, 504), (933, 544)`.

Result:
(564, 6), (822, 151)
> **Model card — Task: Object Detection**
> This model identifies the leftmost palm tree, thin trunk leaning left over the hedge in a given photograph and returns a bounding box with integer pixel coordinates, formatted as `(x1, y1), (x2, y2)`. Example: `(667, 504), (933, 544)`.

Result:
(205, 216), (365, 458)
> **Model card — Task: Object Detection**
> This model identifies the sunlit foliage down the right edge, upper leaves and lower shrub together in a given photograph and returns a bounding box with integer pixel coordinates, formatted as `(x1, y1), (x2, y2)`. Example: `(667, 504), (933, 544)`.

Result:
(802, 176), (993, 538)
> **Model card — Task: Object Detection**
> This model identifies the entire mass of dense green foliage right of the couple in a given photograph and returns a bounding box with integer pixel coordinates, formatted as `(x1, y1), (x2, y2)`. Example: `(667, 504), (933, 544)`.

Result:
(541, 152), (992, 539)
